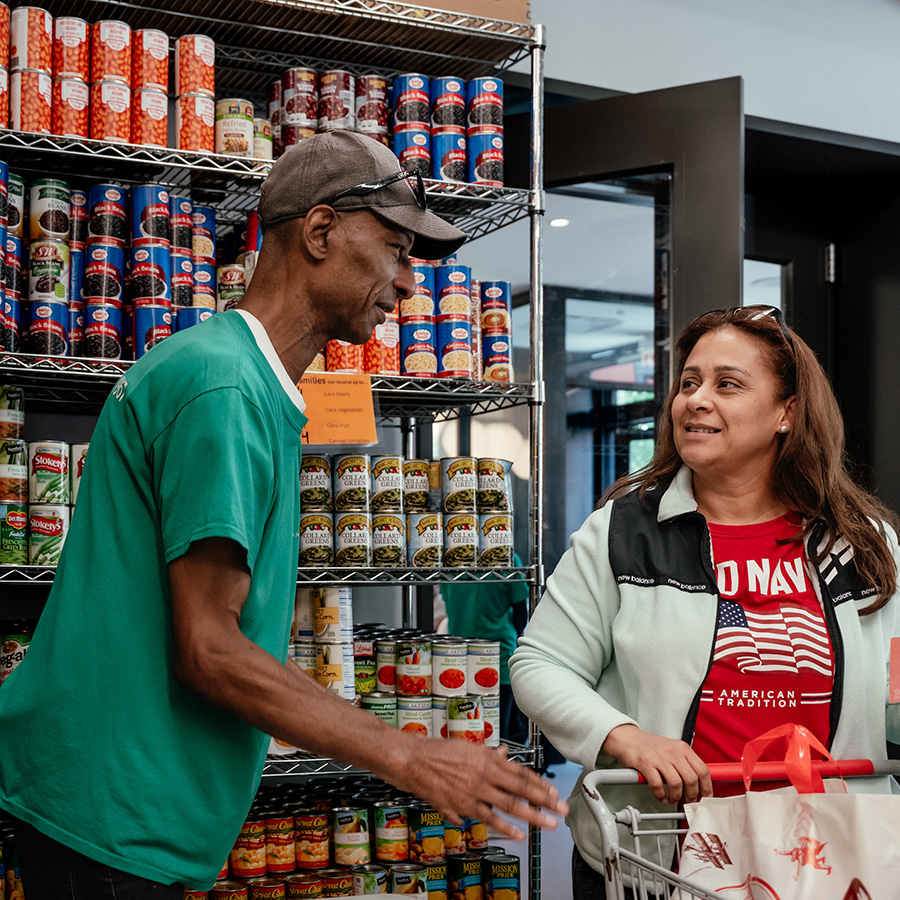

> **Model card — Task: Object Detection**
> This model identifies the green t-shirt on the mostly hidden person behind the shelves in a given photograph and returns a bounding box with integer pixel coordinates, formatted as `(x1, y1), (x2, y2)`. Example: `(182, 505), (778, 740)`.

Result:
(441, 554), (528, 684)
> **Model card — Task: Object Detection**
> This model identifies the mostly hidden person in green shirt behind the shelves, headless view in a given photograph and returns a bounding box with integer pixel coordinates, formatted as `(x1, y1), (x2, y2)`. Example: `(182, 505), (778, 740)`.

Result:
(441, 553), (529, 744)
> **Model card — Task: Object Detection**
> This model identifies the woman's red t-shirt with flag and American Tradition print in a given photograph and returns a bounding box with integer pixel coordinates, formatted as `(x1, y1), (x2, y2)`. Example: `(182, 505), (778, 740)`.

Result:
(692, 514), (834, 796)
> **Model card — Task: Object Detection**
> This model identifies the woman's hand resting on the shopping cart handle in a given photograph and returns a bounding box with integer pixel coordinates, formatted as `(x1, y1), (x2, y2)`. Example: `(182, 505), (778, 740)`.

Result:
(600, 725), (712, 803)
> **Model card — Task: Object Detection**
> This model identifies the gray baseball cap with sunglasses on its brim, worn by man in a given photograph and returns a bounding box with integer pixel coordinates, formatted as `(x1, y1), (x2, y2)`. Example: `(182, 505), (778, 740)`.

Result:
(253, 131), (468, 259)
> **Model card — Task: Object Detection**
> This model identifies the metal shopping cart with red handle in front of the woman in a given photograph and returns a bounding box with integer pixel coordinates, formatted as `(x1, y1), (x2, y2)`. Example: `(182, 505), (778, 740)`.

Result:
(582, 759), (900, 900)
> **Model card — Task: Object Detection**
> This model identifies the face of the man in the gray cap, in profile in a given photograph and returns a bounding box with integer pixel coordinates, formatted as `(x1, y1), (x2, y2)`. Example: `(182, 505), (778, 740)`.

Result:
(327, 211), (415, 344)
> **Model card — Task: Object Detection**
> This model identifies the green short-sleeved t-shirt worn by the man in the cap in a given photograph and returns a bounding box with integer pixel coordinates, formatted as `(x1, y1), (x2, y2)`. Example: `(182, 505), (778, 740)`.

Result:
(0, 311), (306, 889)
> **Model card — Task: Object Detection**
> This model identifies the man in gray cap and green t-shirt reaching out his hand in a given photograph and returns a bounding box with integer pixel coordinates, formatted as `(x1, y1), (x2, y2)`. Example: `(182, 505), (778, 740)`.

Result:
(0, 132), (565, 900)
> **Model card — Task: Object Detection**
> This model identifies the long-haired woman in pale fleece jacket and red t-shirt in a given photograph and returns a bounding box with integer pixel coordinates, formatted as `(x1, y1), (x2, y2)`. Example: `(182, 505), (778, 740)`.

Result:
(511, 306), (900, 900)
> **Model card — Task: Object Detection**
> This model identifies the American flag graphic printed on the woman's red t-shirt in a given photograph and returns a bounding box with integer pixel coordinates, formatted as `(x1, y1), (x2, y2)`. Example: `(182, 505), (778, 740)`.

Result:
(713, 600), (832, 677)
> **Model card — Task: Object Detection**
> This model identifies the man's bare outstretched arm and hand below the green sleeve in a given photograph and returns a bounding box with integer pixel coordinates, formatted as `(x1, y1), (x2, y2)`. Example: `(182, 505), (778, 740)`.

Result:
(169, 538), (566, 839)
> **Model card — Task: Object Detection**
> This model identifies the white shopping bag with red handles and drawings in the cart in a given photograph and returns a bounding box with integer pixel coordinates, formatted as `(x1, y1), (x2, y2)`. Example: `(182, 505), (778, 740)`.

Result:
(679, 725), (900, 900)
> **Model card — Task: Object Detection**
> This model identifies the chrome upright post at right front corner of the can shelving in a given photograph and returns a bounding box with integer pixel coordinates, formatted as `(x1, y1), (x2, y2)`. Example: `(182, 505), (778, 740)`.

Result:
(528, 19), (547, 900)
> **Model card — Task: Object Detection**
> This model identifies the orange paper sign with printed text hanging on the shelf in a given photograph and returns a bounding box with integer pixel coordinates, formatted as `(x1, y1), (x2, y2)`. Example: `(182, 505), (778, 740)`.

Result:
(297, 373), (378, 444)
